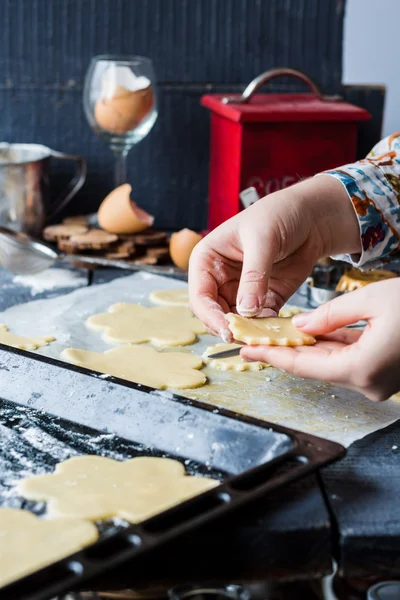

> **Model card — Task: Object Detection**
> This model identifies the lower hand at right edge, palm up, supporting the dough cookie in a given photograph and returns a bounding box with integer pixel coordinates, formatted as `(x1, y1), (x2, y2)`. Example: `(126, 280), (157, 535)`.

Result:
(241, 279), (400, 401)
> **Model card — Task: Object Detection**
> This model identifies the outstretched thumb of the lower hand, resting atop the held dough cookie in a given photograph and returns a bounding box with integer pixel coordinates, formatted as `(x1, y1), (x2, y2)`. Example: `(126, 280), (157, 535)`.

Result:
(292, 286), (372, 335)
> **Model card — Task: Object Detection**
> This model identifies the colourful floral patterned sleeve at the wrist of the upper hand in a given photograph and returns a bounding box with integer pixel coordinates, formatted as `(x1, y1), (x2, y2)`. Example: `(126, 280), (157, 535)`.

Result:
(325, 132), (400, 269)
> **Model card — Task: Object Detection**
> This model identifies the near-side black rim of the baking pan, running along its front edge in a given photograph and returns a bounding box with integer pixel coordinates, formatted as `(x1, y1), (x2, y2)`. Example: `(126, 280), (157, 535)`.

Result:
(0, 426), (344, 600)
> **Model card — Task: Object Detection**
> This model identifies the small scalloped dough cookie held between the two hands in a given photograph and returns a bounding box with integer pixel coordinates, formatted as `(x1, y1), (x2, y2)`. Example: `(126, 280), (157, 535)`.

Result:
(225, 313), (316, 346)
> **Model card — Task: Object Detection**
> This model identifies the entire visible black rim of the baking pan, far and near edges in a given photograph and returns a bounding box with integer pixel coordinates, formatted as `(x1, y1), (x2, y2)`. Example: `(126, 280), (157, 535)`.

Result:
(0, 345), (345, 600)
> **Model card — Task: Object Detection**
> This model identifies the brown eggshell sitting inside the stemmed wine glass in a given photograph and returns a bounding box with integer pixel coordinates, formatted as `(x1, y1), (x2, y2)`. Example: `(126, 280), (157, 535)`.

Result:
(94, 86), (154, 134)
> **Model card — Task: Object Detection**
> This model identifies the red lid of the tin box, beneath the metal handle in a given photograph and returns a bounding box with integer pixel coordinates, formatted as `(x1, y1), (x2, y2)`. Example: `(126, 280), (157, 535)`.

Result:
(201, 93), (371, 123)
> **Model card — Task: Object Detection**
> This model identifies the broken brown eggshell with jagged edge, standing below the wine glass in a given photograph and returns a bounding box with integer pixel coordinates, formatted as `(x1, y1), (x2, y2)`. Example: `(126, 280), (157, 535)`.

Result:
(97, 183), (154, 234)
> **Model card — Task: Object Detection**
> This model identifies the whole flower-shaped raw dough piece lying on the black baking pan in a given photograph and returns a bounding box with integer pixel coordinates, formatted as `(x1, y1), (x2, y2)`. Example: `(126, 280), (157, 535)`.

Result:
(17, 456), (219, 523)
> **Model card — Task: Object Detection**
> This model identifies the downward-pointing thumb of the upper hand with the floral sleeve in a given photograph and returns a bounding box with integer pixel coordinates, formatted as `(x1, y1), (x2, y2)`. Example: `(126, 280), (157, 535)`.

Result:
(236, 239), (275, 317)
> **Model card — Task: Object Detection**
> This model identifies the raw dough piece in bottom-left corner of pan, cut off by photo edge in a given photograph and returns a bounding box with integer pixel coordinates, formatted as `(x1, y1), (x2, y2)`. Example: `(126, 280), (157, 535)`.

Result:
(0, 508), (99, 587)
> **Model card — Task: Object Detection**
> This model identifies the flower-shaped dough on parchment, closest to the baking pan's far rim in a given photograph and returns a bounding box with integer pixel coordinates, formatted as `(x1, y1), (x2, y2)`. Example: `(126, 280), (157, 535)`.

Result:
(61, 346), (207, 390)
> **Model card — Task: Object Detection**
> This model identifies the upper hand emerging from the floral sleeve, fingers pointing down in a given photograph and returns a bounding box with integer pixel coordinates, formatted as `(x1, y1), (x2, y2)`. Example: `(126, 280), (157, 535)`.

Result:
(189, 175), (361, 341)
